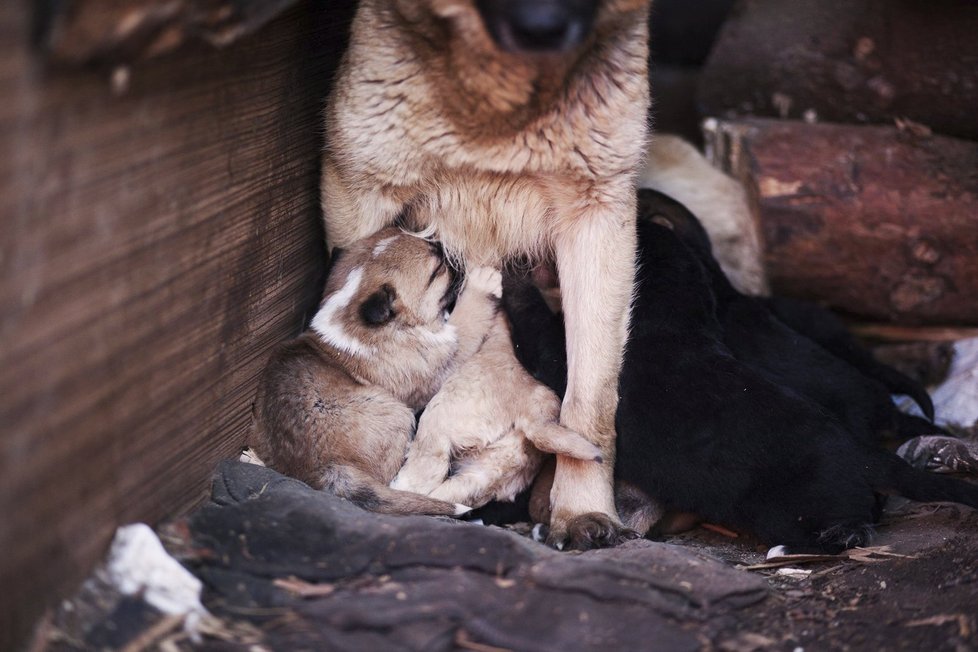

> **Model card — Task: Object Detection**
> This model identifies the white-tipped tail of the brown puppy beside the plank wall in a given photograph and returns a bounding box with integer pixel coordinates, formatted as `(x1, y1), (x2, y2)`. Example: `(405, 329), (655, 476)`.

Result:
(325, 466), (472, 516)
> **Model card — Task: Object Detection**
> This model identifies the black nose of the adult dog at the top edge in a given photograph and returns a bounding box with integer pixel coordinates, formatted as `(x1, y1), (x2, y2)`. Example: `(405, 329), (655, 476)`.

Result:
(476, 0), (598, 52)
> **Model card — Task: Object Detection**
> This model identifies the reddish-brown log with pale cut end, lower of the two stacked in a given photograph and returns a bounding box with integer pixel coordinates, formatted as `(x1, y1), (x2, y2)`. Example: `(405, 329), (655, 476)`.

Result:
(707, 119), (978, 325)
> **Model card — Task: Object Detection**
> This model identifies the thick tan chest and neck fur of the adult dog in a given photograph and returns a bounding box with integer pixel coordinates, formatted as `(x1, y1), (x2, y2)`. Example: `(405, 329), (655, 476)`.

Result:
(327, 2), (648, 265)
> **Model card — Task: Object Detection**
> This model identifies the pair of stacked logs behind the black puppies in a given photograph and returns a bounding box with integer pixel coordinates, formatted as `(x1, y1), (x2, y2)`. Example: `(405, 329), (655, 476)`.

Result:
(653, 0), (978, 336)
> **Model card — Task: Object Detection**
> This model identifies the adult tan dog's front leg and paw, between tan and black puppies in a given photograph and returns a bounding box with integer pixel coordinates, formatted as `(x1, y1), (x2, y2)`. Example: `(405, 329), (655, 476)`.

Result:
(548, 192), (636, 550)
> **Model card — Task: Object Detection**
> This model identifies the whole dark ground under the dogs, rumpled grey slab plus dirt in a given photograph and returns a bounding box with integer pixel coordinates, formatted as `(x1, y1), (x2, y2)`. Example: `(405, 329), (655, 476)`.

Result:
(37, 465), (978, 652)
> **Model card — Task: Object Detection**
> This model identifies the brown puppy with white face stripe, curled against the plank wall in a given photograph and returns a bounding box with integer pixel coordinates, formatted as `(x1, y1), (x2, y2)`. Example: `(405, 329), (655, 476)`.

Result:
(253, 228), (496, 515)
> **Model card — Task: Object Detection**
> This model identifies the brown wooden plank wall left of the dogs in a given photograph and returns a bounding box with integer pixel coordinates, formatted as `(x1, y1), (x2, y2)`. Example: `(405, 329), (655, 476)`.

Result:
(0, 0), (352, 649)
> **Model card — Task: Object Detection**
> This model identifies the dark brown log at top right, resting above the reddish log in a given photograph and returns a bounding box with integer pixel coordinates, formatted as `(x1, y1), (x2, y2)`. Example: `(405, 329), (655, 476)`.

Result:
(699, 0), (978, 139)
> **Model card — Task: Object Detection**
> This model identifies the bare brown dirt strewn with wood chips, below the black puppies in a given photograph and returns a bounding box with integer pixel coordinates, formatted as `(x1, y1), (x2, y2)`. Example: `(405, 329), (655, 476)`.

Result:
(669, 499), (978, 652)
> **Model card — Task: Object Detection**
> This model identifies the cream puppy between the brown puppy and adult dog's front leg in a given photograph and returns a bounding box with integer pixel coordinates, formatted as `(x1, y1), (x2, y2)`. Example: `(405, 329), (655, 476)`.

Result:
(391, 268), (602, 508)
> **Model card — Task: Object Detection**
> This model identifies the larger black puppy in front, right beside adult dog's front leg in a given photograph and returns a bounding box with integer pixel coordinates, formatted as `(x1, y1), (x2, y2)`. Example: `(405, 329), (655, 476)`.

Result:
(504, 191), (978, 553)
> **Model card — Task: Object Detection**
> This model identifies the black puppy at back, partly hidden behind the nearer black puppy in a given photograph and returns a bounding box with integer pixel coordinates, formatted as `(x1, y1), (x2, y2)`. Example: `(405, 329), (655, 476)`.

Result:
(639, 190), (942, 442)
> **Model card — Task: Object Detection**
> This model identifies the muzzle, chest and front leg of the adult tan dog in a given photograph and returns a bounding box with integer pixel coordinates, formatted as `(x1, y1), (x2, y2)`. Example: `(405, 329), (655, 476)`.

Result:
(322, 0), (649, 548)
